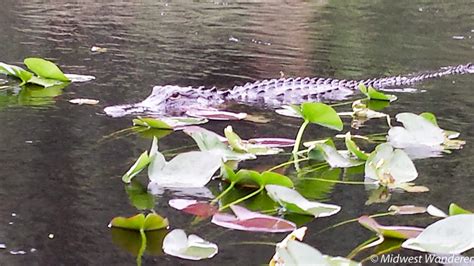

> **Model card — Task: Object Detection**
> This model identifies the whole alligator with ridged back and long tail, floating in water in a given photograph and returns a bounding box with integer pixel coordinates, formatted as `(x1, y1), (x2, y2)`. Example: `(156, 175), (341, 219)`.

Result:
(104, 63), (474, 117)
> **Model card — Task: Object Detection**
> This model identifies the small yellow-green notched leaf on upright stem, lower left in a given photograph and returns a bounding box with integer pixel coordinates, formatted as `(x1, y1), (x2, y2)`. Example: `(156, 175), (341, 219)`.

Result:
(109, 213), (168, 231)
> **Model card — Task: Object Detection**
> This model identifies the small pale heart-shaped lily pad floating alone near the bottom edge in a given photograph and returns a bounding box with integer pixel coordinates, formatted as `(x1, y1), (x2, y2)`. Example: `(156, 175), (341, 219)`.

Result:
(163, 229), (218, 260)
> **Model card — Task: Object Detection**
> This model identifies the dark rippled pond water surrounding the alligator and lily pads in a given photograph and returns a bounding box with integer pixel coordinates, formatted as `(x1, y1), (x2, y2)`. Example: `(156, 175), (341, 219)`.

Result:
(0, 0), (474, 265)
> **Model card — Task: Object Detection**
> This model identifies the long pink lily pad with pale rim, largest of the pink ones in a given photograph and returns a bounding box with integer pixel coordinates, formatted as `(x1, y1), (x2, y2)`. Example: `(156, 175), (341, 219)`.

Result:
(211, 205), (296, 233)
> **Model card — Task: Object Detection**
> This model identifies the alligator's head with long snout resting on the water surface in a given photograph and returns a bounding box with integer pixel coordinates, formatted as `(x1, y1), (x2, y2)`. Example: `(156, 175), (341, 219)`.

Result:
(104, 85), (223, 117)
